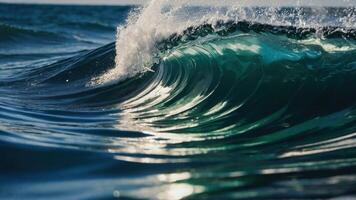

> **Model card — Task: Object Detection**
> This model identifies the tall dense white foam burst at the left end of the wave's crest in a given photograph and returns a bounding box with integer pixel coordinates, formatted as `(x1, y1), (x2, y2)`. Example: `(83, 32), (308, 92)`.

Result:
(94, 0), (218, 83)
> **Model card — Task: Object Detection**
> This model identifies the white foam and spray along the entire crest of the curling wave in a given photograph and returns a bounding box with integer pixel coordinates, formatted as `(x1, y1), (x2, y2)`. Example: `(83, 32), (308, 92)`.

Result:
(93, 0), (356, 84)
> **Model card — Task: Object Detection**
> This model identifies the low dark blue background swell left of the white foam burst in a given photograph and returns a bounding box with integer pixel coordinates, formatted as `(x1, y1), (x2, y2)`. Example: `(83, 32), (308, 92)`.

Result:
(0, 22), (115, 48)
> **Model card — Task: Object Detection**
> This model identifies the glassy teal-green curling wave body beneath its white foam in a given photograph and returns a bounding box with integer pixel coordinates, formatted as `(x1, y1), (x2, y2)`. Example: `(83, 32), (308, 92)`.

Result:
(3, 22), (356, 153)
